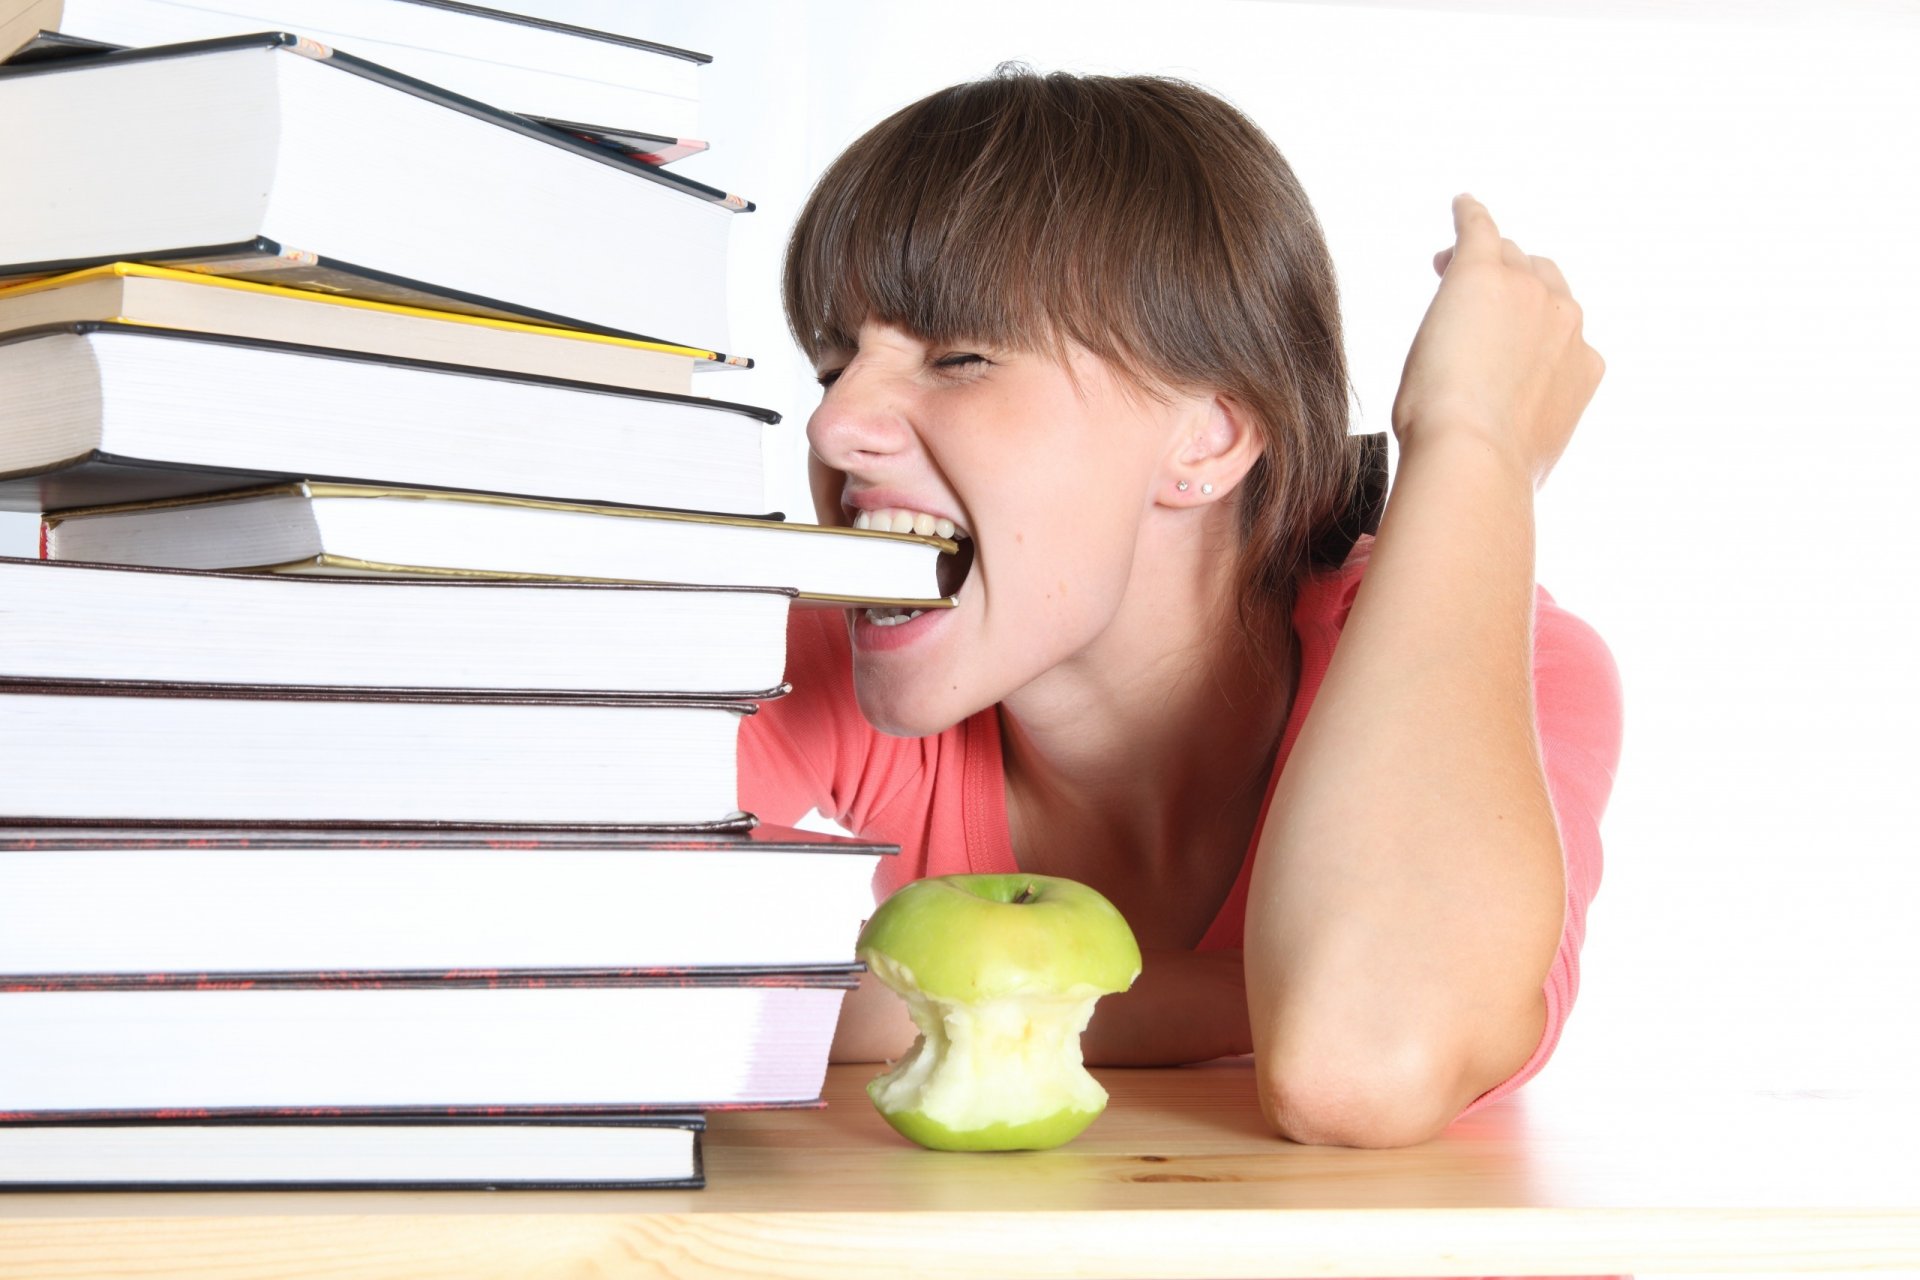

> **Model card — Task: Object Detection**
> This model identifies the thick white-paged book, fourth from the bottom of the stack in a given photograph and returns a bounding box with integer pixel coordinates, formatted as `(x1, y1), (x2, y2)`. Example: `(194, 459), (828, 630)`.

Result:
(0, 679), (755, 825)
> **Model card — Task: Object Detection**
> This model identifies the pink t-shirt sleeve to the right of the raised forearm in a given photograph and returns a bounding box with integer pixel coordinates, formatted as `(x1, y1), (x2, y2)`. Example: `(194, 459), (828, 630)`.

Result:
(1463, 589), (1620, 1115)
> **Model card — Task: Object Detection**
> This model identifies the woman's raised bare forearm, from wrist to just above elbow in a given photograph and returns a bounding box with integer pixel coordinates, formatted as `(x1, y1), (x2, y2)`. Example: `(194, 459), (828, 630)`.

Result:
(1248, 434), (1565, 1143)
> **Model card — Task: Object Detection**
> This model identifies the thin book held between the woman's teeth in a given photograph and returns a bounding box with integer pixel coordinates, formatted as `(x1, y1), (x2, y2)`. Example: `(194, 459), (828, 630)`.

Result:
(40, 484), (966, 608)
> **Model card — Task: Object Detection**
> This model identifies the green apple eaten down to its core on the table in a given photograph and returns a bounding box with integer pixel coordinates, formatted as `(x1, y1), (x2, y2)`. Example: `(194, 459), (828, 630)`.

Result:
(858, 875), (1140, 1151)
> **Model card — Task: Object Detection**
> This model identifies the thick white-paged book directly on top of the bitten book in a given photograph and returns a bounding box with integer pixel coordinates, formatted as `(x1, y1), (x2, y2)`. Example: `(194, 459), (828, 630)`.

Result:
(0, 320), (780, 514)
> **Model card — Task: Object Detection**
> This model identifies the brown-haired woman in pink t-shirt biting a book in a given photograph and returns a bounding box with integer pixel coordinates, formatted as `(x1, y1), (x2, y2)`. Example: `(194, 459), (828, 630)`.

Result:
(743, 69), (1619, 1146)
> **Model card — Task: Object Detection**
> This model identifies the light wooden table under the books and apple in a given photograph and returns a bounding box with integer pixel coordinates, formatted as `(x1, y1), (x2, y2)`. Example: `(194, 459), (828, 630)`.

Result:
(0, 1061), (1920, 1280)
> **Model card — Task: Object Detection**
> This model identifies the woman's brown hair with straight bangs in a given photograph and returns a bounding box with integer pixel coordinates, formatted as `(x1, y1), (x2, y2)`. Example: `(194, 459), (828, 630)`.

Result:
(783, 65), (1367, 635)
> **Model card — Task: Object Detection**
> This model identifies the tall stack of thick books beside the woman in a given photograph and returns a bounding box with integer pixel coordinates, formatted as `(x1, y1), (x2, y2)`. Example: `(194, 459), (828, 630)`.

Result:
(0, 0), (954, 1188)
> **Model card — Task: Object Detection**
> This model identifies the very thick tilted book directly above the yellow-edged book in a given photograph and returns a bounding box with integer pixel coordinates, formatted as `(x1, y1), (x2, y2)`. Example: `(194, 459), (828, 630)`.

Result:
(0, 35), (751, 351)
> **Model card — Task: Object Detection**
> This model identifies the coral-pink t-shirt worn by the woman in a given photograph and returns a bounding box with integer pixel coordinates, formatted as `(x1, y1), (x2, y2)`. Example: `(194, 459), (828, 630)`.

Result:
(739, 537), (1620, 1111)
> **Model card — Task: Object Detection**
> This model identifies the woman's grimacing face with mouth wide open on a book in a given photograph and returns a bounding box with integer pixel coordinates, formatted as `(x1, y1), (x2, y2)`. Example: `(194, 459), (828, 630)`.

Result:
(806, 322), (1192, 737)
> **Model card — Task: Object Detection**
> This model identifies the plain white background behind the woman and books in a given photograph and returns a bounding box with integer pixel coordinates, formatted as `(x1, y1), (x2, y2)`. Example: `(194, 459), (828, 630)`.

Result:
(0, 0), (1920, 1182)
